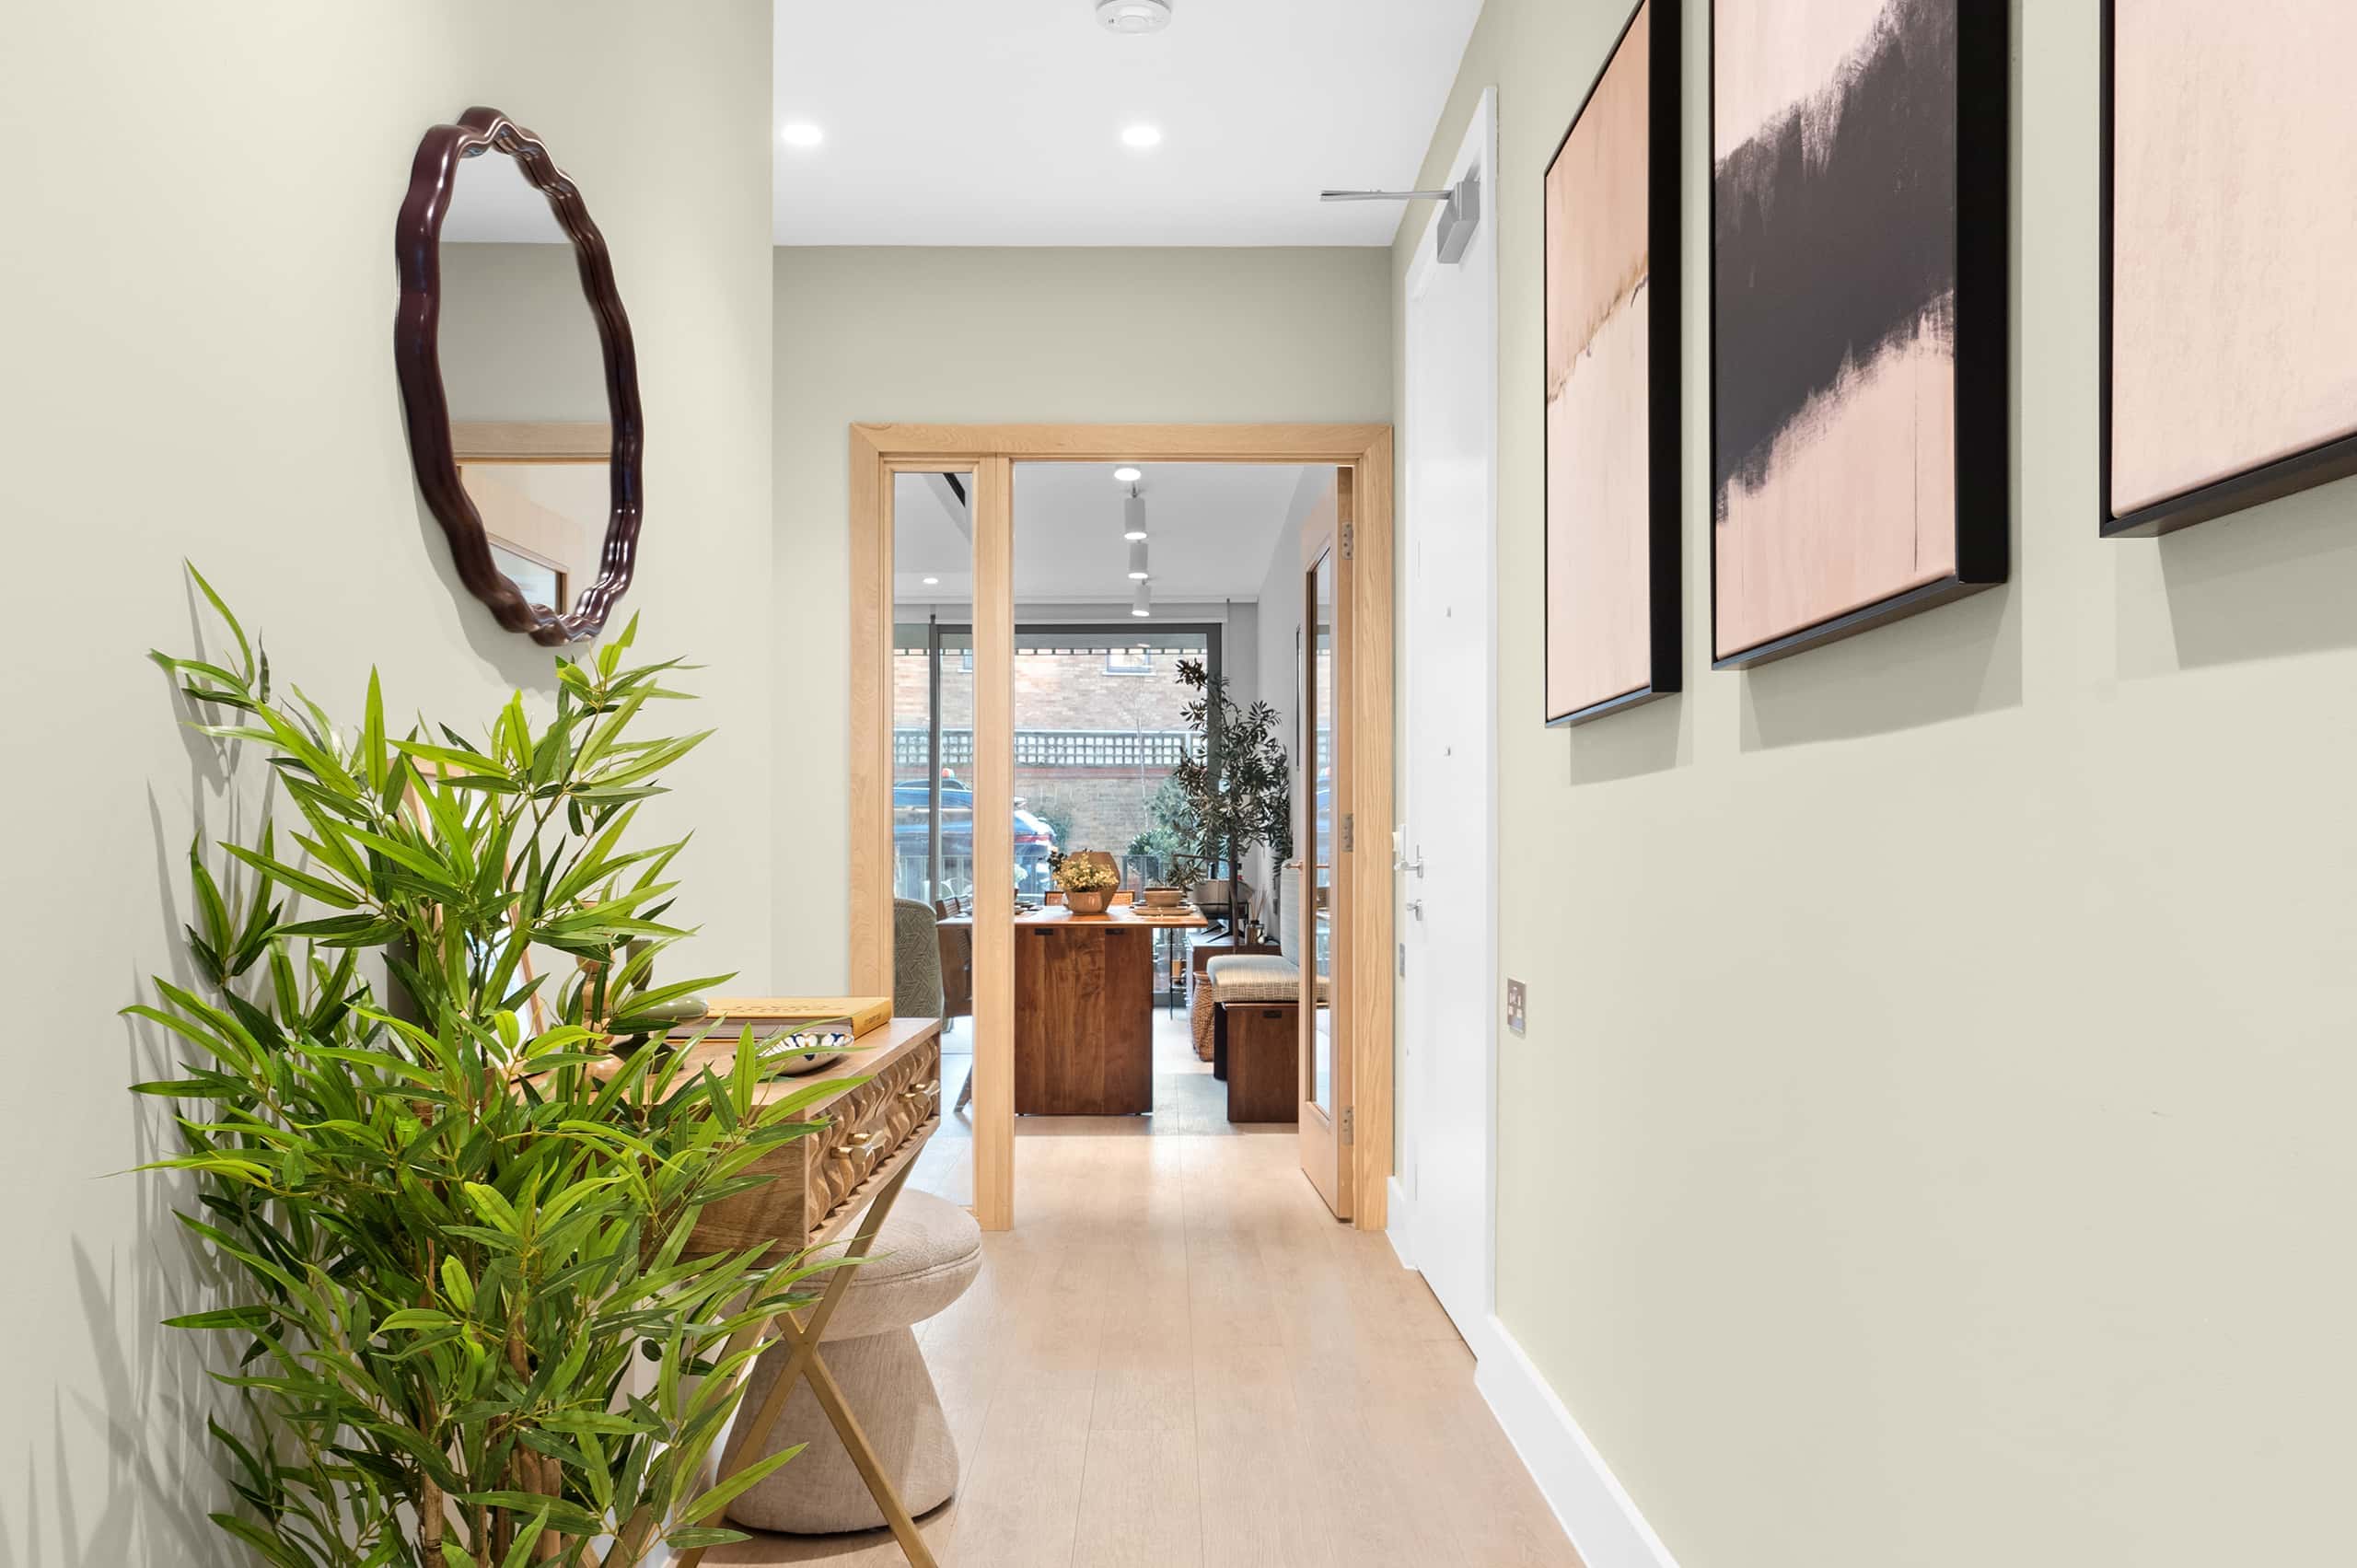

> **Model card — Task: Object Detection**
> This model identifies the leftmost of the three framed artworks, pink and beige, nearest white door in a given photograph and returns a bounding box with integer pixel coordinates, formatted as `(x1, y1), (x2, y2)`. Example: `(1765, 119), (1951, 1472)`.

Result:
(1546, 0), (1680, 724)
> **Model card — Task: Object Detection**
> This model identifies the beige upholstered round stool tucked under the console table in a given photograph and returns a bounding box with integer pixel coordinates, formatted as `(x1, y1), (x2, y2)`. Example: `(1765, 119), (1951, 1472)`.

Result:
(726, 1189), (983, 1535)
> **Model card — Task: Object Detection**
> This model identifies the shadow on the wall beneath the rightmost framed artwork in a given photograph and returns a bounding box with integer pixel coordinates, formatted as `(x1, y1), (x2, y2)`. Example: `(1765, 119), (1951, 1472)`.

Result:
(2107, 483), (2357, 679)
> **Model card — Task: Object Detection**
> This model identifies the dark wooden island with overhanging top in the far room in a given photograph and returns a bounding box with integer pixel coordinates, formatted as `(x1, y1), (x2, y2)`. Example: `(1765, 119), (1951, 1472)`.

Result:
(940, 903), (1209, 1115)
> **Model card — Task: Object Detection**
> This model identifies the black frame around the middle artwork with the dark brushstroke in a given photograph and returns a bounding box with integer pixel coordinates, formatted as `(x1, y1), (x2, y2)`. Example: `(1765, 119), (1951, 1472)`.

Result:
(1704, 0), (2013, 669)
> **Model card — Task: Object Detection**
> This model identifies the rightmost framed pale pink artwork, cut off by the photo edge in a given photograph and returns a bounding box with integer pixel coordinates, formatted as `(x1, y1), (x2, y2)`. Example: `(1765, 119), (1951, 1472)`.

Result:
(2103, 0), (2357, 535)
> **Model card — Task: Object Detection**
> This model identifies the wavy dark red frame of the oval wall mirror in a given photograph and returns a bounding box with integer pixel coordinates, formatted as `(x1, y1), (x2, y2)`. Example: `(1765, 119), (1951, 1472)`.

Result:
(394, 109), (645, 646)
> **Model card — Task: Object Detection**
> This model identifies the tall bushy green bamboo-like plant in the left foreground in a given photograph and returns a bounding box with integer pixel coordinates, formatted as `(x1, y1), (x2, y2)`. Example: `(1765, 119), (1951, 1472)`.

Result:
(127, 573), (839, 1568)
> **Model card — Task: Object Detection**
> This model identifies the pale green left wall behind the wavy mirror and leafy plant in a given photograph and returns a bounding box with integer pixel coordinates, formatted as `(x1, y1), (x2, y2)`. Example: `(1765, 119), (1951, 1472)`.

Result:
(0, 0), (775, 1568)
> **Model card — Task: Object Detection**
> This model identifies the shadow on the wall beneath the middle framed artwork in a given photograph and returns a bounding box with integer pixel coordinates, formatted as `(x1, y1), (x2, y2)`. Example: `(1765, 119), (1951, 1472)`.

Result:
(1742, 583), (2022, 752)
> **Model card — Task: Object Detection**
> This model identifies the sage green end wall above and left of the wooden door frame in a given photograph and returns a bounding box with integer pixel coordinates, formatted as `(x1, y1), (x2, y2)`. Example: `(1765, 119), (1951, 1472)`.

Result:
(775, 245), (1390, 991)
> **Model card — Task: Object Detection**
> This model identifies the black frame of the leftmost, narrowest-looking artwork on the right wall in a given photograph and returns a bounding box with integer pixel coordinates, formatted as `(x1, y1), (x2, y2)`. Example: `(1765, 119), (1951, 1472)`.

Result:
(1539, 0), (1685, 728)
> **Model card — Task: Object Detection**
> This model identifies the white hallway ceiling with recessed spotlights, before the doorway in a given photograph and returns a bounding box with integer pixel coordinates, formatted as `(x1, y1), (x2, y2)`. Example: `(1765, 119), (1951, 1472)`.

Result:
(771, 0), (1480, 245)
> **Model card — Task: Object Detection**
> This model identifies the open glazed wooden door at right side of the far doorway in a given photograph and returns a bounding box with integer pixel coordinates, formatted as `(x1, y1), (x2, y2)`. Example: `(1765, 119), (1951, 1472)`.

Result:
(1284, 474), (1355, 1219)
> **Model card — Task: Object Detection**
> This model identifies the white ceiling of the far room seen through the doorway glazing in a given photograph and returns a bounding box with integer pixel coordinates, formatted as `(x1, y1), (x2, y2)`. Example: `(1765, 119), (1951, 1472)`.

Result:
(893, 462), (1331, 609)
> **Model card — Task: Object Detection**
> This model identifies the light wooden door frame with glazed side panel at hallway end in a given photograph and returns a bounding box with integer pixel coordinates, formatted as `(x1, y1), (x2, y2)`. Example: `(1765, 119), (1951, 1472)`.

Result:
(846, 424), (1393, 1231)
